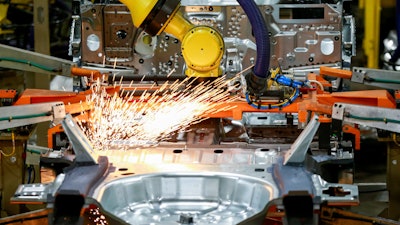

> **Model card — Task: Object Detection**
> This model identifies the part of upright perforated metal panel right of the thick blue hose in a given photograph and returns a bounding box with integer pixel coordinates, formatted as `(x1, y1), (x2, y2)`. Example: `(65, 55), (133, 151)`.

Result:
(264, 4), (342, 69)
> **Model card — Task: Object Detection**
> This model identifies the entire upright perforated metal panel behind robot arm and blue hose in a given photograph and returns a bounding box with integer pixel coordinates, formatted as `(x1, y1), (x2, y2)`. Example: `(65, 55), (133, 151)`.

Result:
(79, 0), (354, 77)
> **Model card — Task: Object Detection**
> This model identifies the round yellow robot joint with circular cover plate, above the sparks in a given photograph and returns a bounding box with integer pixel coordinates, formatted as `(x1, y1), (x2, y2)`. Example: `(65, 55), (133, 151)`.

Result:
(181, 26), (224, 77)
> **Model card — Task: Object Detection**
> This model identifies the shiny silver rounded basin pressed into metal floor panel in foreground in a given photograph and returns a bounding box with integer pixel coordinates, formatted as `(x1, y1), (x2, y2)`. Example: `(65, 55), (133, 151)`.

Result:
(94, 172), (276, 224)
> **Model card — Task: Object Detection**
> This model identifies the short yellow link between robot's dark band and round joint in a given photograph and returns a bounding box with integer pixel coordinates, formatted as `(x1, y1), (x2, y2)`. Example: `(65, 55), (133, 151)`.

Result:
(160, 11), (193, 41)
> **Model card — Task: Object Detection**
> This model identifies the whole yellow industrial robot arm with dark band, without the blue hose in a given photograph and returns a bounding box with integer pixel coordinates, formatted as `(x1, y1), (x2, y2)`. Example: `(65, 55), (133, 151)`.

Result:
(121, 0), (225, 77)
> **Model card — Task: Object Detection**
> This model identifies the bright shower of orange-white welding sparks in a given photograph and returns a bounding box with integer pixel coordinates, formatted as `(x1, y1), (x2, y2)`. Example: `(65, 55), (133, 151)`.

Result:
(79, 74), (235, 150)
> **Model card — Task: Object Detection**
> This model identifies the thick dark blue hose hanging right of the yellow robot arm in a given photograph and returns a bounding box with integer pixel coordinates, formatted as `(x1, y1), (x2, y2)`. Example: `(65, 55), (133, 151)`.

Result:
(237, 0), (271, 78)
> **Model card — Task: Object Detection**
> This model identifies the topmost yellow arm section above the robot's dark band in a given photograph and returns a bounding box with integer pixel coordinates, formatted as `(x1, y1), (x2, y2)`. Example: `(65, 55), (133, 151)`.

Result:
(120, 0), (158, 27)
